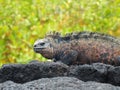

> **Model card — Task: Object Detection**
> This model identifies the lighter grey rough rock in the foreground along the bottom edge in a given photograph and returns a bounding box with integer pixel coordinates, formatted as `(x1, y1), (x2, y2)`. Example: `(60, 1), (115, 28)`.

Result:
(0, 77), (120, 90)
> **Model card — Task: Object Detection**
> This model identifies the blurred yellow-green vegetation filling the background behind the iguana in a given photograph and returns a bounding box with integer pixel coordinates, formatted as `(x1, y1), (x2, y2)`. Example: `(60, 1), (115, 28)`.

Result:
(0, 0), (120, 65)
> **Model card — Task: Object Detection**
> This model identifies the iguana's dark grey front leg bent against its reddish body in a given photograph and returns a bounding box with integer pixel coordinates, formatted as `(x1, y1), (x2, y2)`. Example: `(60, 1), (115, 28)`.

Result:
(54, 50), (78, 65)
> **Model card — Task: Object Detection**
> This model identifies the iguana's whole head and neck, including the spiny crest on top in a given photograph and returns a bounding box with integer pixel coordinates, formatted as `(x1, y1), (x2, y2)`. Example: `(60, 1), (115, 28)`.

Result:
(34, 32), (71, 59)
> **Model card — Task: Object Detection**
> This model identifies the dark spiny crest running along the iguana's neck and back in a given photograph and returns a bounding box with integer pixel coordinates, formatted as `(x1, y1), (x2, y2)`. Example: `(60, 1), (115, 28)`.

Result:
(46, 31), (120, 44)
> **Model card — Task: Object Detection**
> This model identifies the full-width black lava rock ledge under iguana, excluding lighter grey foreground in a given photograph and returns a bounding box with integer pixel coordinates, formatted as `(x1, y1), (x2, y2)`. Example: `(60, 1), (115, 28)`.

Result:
(0, 61), (120, 90)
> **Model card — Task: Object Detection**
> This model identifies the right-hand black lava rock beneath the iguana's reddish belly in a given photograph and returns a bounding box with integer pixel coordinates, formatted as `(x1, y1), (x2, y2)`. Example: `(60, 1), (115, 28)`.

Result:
(69, 63), (112, 83)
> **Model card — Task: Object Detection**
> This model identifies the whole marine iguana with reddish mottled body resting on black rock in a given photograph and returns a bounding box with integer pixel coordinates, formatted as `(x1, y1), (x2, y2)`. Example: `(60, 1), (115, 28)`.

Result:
(34, 32), (120, 66)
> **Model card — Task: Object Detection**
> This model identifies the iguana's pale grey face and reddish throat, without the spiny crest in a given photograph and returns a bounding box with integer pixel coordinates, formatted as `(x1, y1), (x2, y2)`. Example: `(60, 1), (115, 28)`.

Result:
(33, 38), (54, 59)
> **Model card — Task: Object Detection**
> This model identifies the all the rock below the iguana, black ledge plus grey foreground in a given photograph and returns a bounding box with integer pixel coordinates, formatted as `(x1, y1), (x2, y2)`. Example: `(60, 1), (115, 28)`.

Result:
(0, 61), (120, 90)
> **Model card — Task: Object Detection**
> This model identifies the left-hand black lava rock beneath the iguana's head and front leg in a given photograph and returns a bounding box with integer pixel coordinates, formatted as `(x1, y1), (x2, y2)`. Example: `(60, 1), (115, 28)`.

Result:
(0, 62), (68, 83)
